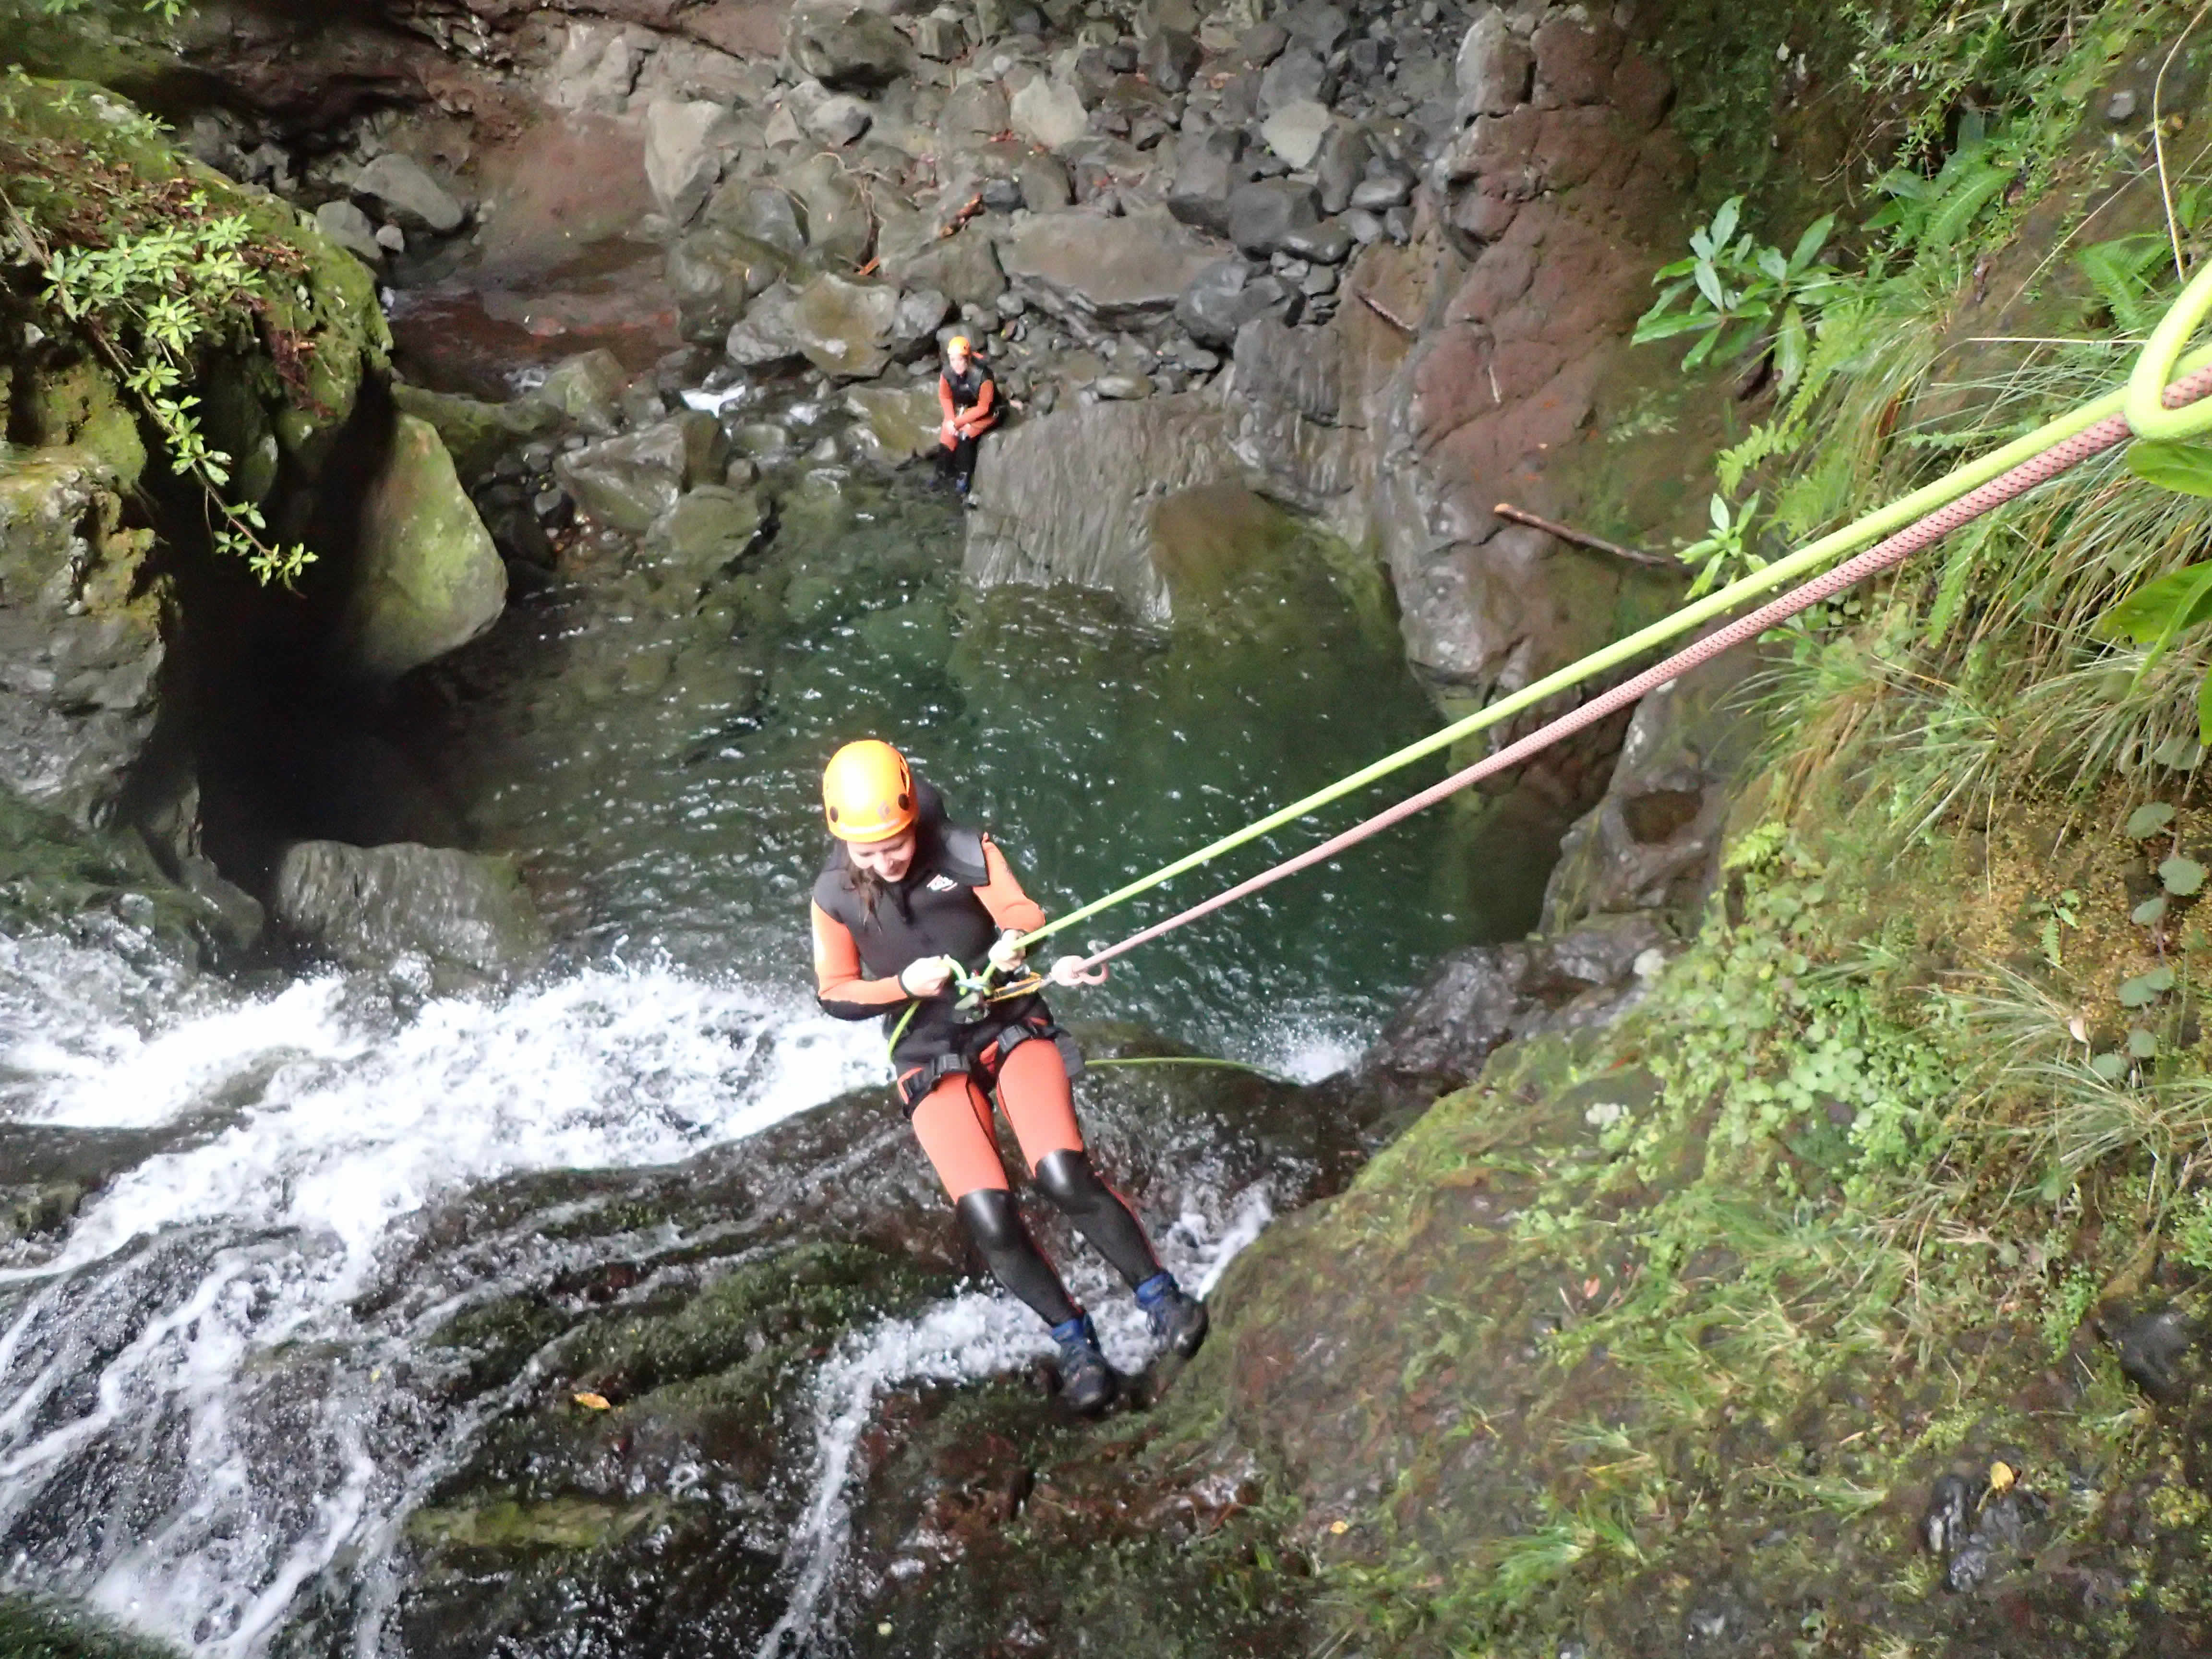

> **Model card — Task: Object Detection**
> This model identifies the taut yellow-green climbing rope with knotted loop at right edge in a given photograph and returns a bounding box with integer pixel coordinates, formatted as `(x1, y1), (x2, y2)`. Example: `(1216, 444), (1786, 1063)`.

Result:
(1022, 310), (2212, 947)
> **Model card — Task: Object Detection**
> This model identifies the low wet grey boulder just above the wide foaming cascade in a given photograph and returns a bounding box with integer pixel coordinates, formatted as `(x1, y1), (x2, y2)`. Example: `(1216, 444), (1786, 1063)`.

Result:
(270, 841), (546, 978)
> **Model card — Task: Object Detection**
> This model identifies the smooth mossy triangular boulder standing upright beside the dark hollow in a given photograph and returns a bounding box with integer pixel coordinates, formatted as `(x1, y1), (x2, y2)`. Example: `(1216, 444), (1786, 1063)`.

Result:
(336, 414), (506, 681)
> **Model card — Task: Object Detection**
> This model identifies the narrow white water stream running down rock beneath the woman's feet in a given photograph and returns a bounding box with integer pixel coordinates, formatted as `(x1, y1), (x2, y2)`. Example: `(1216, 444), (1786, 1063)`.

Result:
(754, 1183), (1274, 1659)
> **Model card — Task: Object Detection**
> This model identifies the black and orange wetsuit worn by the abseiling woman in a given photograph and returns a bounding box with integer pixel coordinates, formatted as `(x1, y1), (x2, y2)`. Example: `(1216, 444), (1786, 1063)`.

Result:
(810, 781), (1161, 1327)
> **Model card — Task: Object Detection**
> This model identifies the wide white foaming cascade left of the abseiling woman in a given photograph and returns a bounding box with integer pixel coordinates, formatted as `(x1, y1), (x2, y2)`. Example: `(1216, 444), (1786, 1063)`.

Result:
(0, 942), (885, 1659)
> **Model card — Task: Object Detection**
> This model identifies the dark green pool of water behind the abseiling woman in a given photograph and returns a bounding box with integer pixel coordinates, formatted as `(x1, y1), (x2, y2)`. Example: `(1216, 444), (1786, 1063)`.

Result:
(431, 462), (1562, 1069)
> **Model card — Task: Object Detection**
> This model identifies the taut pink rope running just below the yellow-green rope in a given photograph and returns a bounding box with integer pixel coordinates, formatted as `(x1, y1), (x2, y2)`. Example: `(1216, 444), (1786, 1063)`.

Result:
(1082, 370), (2212, 971)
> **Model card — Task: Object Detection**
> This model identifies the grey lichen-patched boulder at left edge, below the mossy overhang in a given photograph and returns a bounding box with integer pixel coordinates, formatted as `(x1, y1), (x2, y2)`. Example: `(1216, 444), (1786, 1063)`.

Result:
(0, 449), (168, 825)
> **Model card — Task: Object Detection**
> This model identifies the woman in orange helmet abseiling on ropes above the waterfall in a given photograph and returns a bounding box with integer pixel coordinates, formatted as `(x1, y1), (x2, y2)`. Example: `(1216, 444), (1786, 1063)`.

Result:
(812, 741), (1205, 1411)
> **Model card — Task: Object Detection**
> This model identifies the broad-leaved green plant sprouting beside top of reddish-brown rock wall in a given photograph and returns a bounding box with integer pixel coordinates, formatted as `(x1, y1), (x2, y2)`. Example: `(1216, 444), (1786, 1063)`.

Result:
(1635, 197), (1838, 392)
